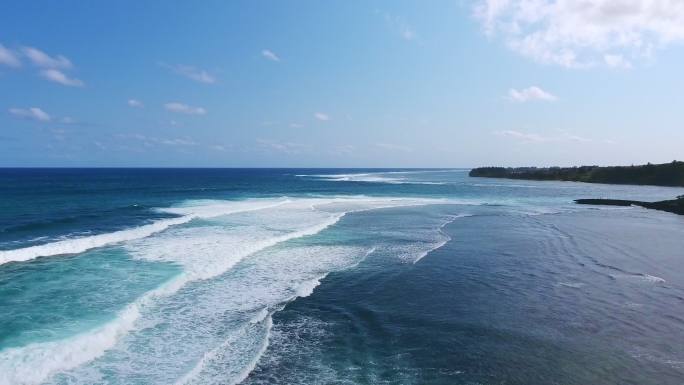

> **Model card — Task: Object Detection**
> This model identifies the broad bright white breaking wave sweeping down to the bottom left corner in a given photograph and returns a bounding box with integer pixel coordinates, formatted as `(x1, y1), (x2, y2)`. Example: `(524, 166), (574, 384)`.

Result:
(6, 196), (454, 384)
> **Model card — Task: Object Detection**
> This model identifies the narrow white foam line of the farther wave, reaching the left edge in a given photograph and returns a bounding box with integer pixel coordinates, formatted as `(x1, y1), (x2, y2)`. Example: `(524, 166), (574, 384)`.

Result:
(0, 200), (288, 265)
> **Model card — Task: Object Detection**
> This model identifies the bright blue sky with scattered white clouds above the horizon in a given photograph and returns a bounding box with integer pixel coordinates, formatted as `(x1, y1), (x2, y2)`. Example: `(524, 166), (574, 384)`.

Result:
(0, 0), (684, 167)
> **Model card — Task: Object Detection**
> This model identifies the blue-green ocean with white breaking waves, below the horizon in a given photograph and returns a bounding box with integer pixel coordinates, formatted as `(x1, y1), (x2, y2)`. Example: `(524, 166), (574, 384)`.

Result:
(0, 169), (684, 385)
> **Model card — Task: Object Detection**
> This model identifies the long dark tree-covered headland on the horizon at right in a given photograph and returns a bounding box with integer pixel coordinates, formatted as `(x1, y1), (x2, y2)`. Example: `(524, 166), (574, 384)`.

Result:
(469, 161), (684, 187)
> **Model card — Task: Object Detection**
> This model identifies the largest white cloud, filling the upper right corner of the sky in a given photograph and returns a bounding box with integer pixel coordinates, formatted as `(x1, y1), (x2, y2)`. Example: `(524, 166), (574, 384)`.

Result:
(475, 0), (684, 68)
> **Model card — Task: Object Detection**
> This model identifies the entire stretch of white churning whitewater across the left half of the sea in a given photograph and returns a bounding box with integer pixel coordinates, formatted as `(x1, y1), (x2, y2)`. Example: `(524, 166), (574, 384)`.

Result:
(0, 196), (460, 385)
